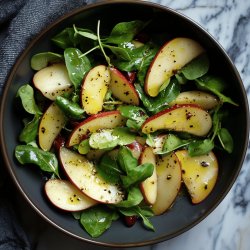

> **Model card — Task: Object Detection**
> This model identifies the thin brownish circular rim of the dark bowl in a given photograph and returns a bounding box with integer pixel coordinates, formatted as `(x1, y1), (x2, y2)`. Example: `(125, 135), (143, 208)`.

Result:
(0, 0), (250, 248)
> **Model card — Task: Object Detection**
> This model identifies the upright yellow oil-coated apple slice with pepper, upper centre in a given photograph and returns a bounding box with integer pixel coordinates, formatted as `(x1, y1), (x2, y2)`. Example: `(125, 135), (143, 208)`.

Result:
(81, 65), (110, 115)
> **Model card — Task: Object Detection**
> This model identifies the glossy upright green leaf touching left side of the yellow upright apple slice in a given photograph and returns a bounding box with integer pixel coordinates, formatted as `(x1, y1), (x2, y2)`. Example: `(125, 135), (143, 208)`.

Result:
(64, 48), (91, 89)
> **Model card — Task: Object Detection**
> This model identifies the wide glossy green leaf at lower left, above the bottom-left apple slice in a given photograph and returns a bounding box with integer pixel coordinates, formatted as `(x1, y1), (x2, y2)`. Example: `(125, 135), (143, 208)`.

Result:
(15, 145), (59, 177)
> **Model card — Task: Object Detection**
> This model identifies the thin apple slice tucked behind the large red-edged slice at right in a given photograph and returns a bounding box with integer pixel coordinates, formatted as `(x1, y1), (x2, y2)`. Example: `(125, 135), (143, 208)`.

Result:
(169, 90), (219, 110)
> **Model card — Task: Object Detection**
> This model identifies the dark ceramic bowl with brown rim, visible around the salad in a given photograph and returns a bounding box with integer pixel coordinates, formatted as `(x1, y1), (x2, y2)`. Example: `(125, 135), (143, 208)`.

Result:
(0, 1), (249, 247)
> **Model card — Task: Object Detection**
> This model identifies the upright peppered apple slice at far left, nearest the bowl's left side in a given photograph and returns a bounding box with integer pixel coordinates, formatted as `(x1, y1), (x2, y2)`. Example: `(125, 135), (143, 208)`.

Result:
(38, 102), (67, 151)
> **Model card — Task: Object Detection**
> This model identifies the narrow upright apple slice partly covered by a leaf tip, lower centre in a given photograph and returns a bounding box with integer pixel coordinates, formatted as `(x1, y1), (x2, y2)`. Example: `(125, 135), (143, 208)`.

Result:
(139, 147), (157, 205)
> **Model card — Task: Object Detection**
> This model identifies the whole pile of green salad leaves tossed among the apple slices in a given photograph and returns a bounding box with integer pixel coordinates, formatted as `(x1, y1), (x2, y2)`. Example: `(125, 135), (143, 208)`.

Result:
(15, 20), (237, 237)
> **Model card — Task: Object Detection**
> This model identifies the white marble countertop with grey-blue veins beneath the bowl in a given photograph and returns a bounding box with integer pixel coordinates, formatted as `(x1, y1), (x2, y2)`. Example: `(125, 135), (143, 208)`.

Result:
(13, 0), (250, 250)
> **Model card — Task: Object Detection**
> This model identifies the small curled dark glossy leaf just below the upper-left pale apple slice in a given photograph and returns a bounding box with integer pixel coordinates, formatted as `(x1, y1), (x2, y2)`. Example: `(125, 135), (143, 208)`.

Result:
(55, 96), (84, 120)
